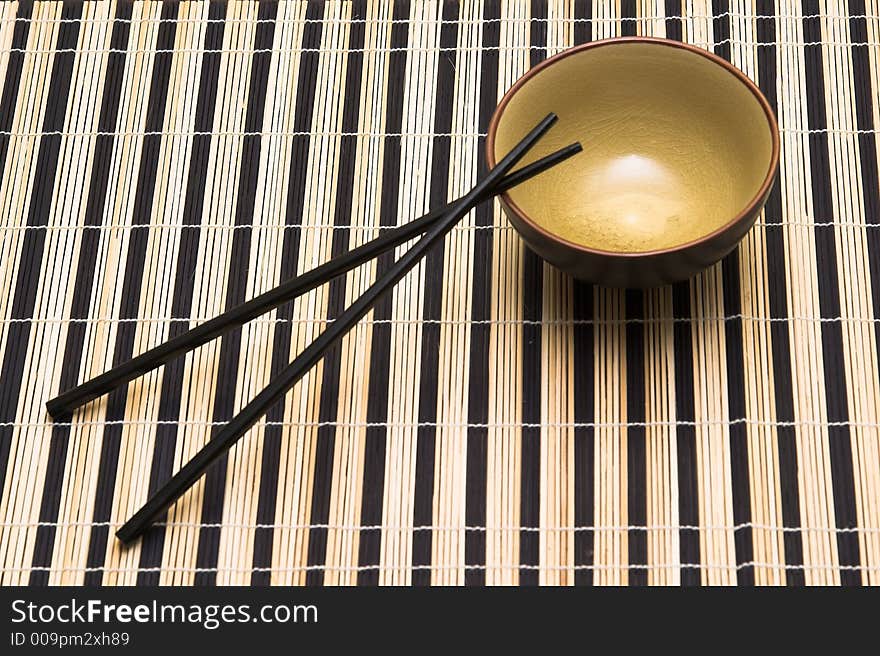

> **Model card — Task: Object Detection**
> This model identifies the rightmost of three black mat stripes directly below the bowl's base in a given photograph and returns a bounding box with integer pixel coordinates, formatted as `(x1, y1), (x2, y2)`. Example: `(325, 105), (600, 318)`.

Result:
(666, 0), (700, 586)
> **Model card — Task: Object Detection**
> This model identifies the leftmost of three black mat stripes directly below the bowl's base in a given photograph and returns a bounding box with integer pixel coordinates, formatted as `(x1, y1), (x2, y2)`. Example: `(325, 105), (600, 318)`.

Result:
(572, 0), (596, 585)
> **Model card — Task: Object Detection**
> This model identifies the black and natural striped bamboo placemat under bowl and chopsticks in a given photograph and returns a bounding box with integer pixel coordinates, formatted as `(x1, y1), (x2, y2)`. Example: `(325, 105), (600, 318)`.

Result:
(0, 0), (880, 585)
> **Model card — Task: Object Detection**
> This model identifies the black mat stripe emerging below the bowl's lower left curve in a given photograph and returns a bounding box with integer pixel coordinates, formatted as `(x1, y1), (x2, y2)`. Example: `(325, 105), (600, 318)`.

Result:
(519, 0), (547, 585)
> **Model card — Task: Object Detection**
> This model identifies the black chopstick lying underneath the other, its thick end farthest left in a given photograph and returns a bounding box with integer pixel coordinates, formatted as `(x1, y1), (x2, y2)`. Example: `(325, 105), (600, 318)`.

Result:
(46, 144), (581, 419)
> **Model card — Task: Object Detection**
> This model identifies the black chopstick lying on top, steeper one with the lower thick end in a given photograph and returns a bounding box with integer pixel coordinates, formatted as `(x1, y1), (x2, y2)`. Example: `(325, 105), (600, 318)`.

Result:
(116, 114), (572, 543)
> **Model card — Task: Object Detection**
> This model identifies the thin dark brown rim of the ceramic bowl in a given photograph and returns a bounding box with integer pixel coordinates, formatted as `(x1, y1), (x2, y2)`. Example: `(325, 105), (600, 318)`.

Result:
(486, 36), (779, 257)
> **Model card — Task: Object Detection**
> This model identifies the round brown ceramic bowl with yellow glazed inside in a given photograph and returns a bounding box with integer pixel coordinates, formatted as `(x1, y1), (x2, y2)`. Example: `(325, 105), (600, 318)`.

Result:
(486, 37), (779, 287)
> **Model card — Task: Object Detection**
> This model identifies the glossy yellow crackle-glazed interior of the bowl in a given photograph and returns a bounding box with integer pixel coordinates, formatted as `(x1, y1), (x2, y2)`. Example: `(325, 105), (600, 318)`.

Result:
(494, 41), (773, 253)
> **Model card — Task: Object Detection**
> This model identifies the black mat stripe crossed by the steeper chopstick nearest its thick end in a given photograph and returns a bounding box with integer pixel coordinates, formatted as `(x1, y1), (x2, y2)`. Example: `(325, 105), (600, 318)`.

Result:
(136, 2), (226, 585)
